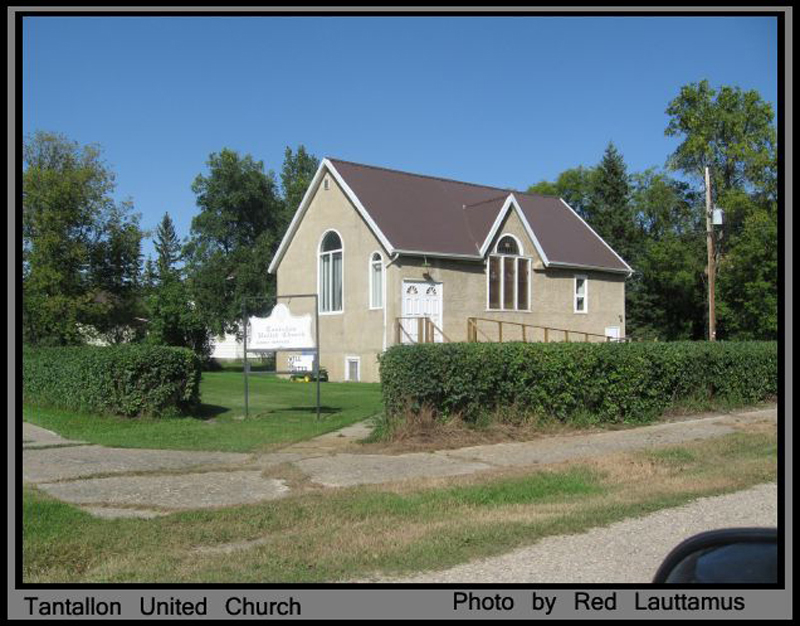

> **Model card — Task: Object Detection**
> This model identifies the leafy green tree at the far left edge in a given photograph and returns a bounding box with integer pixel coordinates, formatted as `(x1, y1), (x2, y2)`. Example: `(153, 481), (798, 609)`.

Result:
(22, 131), (142, 345)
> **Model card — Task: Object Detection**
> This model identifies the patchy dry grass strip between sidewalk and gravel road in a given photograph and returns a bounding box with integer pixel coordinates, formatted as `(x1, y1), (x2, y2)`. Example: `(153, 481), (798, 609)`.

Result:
(23, 425), (777, 583)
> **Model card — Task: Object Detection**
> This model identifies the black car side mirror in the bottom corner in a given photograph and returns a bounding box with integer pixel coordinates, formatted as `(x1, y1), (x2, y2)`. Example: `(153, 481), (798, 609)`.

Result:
(653, 528), (778, 584)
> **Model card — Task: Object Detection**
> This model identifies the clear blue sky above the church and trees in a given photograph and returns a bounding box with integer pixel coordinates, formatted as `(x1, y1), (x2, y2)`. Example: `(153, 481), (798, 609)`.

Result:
(23, 17), (777, 254)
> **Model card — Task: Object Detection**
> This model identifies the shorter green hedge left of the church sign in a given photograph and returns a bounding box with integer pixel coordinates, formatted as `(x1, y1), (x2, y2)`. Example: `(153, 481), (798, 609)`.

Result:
(22, 344), (200, 417)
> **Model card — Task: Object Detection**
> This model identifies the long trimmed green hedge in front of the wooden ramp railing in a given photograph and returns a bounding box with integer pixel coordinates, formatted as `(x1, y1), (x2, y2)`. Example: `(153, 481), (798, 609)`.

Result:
(380, 341), (778, 422)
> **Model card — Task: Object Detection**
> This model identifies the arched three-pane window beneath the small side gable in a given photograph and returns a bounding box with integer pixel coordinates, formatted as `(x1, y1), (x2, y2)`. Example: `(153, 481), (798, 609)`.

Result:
(487, 235), (531, 311)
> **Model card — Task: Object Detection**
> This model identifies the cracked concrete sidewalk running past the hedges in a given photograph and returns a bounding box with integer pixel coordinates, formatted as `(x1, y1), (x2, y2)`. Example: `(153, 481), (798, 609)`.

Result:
(23, 407), (777, 517)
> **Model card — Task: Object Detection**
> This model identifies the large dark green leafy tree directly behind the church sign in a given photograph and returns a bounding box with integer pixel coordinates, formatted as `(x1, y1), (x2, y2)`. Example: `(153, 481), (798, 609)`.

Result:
(184, 148), (284, 334)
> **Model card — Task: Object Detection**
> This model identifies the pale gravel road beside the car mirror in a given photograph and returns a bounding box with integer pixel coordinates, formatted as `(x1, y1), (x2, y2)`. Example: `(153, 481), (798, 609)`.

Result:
(369, 483), (778, 584)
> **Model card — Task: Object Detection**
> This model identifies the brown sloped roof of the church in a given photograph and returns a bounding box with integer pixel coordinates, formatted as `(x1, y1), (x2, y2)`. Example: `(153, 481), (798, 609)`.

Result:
(328, 159), (630, 271)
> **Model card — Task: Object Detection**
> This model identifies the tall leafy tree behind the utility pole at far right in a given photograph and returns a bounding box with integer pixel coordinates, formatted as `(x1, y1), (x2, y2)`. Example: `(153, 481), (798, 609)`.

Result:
(665, 80), (778, 338)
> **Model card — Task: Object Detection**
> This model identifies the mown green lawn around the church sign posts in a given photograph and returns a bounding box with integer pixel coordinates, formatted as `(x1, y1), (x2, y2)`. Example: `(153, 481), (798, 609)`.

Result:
(23, 371), (382, 452)
